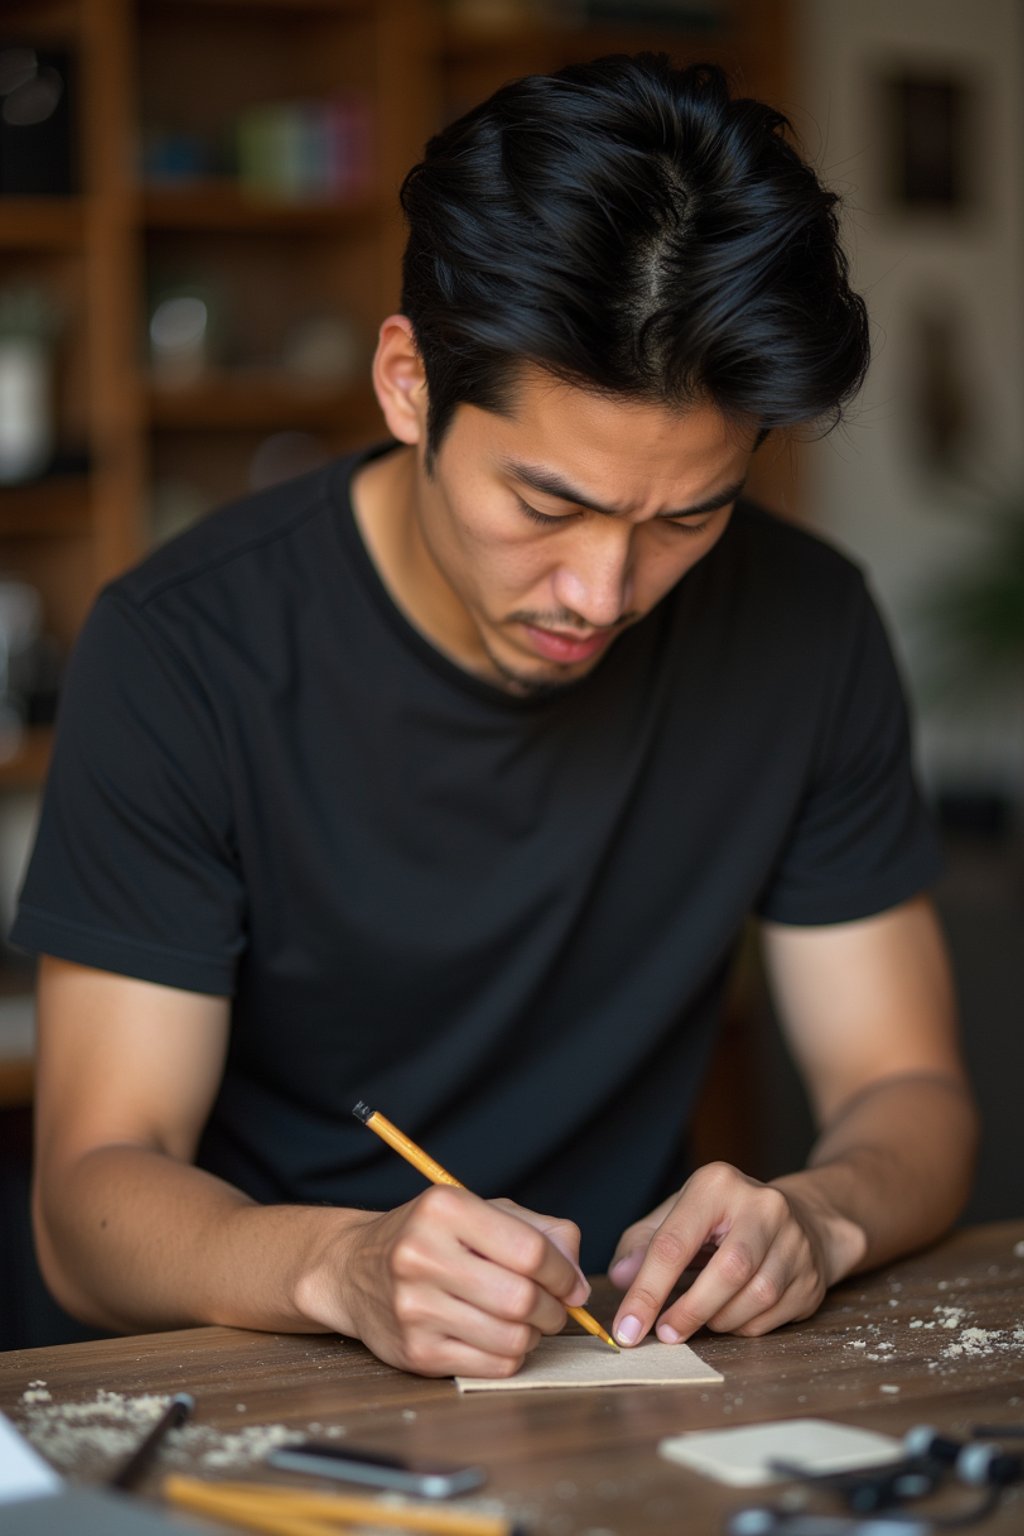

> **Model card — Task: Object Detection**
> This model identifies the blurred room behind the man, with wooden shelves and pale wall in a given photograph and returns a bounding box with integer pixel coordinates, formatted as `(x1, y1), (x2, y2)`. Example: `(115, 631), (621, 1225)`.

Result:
(0, 0), (1024, 1347)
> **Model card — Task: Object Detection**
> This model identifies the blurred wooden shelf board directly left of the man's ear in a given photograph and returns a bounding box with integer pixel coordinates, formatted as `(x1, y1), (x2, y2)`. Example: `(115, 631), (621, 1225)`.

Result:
(147, 370), (370, 432)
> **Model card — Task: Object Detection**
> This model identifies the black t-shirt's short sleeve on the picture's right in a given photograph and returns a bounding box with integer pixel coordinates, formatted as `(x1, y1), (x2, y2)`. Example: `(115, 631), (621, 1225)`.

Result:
(757, 576), (941, 925)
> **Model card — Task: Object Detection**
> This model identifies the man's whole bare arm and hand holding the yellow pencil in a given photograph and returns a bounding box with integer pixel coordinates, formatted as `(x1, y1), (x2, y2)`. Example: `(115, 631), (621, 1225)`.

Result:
(32, 957), (585, 1375)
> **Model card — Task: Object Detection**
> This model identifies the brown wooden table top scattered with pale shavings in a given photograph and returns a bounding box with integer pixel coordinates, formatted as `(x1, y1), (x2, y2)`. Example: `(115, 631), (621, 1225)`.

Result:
(0, 1221), (1024, 1536)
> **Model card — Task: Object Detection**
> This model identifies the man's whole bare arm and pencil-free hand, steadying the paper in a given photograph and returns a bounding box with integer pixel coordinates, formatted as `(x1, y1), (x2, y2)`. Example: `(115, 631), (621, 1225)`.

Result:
(611, 897), (978, 1342)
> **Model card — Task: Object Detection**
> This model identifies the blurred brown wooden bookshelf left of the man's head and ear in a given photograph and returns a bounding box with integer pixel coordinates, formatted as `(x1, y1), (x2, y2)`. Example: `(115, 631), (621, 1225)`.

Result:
(0, 0), (438, 790)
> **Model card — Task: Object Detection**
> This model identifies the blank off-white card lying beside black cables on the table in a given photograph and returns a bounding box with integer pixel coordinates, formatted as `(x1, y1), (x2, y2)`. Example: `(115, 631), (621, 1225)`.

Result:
(659, 1419), (904, 1488)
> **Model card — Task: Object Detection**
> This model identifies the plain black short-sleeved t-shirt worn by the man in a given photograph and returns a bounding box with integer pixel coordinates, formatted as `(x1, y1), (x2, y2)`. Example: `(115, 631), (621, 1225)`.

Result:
(12, 445), (938, 1267)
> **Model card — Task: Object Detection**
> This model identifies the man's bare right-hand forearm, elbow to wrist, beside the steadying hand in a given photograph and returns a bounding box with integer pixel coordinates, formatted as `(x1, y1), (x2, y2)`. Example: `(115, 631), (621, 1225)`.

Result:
(772, 1074), (978, 1284)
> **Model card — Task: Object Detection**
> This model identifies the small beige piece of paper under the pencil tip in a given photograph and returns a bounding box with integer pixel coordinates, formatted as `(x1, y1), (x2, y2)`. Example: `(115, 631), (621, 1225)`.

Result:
(454, 1335), (722, 1392)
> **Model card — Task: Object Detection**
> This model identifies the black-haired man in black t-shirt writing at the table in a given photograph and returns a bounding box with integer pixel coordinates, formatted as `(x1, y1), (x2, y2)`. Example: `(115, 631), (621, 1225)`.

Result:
(14, 57), (975, 1375)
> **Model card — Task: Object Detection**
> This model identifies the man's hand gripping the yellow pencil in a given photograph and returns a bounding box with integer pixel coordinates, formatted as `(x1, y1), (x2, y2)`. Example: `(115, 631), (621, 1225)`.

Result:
(316, 1186), (590, 1376)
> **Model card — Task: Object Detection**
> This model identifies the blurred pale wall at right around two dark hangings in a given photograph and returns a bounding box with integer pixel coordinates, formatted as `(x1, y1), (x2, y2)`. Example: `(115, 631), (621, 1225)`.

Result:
(788, 0), (1024, 806)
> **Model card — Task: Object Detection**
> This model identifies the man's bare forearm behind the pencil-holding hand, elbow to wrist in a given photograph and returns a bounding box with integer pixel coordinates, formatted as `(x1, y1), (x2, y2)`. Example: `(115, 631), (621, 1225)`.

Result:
(34, 1146), (379, 1333)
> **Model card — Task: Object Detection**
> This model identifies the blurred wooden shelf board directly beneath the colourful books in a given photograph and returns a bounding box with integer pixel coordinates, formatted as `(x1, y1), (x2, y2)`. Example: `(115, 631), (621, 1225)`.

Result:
(140, 182), (381, 235)
